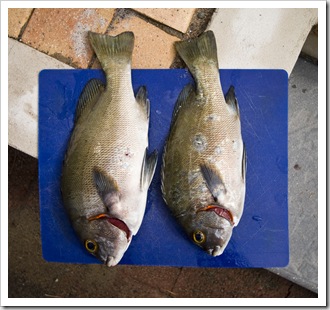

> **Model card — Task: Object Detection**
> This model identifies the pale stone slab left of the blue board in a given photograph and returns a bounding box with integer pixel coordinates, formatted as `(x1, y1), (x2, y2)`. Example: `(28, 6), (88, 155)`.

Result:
(8, 38), (71, 157)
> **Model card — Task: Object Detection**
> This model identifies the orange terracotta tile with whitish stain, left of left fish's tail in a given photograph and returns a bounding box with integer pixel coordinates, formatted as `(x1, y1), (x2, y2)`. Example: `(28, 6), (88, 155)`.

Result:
(22, 9), (115, 68)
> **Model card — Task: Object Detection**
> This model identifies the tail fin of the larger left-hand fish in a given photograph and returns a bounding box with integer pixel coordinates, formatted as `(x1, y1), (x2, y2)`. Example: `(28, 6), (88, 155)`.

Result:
(88, 31), (134, 68)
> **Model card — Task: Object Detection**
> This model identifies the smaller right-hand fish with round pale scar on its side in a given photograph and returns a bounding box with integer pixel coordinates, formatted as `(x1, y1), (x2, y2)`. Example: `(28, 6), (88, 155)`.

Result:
(161, 31), (246, 256)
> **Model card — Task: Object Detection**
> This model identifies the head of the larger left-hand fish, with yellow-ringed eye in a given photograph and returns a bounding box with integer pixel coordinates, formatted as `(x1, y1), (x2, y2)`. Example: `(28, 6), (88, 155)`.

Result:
(75, 216), (131, 267)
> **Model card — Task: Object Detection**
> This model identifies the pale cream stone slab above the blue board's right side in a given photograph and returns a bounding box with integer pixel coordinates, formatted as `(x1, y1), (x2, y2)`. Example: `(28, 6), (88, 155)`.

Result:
(208, 8), (318, 74)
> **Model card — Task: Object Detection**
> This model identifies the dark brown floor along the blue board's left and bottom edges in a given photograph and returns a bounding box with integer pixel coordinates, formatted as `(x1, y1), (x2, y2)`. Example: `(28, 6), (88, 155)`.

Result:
(8, 147), (317, 298)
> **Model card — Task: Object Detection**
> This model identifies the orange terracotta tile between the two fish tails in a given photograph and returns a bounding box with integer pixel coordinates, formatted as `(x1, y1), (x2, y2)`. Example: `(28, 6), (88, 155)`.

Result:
(109, 16), (179, 69)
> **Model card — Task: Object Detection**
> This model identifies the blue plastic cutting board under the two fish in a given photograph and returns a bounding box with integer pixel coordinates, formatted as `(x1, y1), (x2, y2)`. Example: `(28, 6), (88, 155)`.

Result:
(39, 69), (289, 267)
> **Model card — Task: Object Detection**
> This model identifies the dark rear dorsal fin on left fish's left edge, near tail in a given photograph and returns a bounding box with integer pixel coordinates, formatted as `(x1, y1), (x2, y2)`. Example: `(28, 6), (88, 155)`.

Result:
(75, 79), (104, 122)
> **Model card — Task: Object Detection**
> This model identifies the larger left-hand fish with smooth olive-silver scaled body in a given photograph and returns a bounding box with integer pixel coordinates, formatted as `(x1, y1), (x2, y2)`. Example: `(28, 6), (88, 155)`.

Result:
(61, 32), (158, 267)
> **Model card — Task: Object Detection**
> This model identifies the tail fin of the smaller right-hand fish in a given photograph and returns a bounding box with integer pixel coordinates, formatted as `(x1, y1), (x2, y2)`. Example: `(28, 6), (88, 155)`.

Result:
(175, 30), (219, 74)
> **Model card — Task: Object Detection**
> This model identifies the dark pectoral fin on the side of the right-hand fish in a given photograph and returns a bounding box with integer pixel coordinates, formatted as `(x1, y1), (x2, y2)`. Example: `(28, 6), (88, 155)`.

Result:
(200, 164), (226, 202)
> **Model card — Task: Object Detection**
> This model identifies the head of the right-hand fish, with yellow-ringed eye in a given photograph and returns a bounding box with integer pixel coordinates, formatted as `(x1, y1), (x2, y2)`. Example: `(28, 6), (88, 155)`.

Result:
(179, 206), (233, 256)
